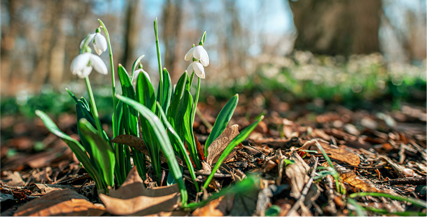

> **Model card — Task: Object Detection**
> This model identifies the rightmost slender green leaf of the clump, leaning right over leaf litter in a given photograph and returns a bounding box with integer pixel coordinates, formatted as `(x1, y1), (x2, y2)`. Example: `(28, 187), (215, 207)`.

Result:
(203, 116), (264, 189)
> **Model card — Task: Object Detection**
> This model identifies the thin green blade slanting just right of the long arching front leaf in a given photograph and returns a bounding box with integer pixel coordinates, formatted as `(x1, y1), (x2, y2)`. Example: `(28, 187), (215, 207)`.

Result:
(157, 103), (199, 192)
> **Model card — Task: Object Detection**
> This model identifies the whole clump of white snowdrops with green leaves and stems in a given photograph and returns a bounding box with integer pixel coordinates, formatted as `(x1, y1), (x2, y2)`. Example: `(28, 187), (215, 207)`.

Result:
(36, 19), (263, 206)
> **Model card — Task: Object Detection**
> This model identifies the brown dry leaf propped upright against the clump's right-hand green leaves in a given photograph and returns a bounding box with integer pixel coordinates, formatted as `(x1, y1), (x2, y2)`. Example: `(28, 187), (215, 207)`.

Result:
(206, 124), (239, 165)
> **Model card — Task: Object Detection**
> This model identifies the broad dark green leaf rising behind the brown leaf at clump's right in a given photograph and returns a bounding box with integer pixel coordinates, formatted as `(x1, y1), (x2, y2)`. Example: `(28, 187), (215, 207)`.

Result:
(205, 94), (239, 157)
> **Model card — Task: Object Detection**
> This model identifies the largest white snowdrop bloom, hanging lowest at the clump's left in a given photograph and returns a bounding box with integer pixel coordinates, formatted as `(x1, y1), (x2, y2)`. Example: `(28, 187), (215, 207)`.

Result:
(71, 53), (108, 78)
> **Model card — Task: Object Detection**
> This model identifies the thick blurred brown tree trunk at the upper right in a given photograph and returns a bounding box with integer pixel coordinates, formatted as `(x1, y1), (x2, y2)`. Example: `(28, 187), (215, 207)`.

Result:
(290, 0), (381, 56)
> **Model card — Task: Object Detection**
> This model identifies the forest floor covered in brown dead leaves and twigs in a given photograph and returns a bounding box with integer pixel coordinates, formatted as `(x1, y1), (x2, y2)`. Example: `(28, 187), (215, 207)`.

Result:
(0, 100), (427, 216)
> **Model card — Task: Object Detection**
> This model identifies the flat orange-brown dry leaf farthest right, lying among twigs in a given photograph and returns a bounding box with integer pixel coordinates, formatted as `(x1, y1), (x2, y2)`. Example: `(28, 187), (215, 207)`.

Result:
(299, 139), (360, 167)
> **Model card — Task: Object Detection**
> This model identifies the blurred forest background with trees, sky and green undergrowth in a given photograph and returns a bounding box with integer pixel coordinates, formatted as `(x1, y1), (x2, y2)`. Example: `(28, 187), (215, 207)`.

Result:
(1, 0), (426, 117)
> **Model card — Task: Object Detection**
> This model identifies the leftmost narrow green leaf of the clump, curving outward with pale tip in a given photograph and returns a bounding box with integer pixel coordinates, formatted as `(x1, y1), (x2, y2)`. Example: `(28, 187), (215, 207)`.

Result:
(36, 110), (105, 189)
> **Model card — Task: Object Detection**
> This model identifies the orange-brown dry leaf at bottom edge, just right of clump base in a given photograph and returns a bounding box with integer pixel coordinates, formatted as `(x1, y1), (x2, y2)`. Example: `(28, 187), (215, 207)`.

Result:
(192, 195), (234, 216)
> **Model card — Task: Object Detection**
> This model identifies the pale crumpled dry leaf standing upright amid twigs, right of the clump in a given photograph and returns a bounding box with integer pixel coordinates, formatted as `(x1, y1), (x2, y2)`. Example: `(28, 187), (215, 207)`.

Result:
(285, 152), (310, 198)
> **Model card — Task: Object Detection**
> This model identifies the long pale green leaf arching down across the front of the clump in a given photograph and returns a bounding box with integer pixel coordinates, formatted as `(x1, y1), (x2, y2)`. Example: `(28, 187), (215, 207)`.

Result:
(117, 95), (188, 204)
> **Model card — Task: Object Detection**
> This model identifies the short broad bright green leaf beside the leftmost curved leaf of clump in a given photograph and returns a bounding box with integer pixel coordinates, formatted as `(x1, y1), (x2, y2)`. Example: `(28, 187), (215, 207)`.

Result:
(79, 119), (115, 187)
